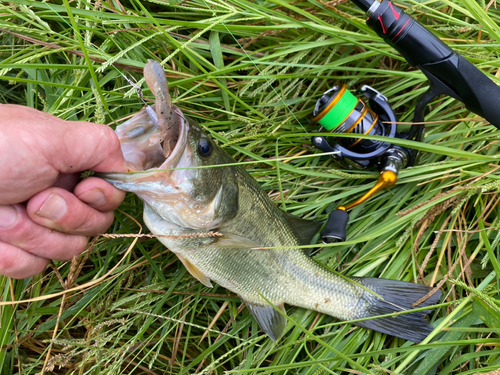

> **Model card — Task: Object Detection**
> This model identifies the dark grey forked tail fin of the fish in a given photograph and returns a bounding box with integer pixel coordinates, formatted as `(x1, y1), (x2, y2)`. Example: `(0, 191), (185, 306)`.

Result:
(356, 278), (441, 342)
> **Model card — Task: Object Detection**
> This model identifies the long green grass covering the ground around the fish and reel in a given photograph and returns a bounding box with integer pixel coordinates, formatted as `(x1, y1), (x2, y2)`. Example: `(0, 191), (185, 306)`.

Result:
(0, 0), (500, 375)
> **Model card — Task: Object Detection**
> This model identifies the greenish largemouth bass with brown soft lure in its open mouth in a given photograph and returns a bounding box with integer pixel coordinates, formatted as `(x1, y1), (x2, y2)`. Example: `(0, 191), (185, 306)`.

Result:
(104, 61), (441, 342)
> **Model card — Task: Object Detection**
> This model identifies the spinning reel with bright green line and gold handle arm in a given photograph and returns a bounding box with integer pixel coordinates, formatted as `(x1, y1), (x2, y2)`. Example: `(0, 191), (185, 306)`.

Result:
(312, 85), (420, 243)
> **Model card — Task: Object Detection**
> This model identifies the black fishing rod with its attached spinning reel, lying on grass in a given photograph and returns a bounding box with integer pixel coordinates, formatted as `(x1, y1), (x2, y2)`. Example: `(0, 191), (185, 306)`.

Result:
(312, 0), (500, 242)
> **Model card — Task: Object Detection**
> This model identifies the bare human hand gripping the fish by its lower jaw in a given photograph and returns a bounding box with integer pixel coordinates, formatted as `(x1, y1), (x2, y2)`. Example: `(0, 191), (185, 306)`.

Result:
(0, 104), (127, 279)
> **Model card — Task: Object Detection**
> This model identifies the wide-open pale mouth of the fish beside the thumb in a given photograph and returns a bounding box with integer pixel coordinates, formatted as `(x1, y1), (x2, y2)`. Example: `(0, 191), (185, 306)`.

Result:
(99, 106), (189, 185)
